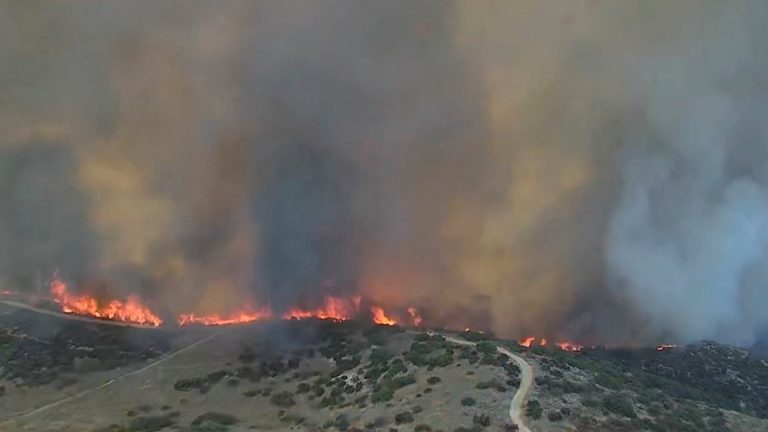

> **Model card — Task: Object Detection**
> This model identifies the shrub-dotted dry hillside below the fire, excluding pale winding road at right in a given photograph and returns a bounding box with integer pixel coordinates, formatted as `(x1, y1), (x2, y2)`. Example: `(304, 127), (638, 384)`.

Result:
(0, 304), (768, 432)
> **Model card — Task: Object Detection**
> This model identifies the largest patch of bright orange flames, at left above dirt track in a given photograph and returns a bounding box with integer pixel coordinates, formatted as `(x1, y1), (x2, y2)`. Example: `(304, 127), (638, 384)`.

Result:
(51, 278), (163, 327)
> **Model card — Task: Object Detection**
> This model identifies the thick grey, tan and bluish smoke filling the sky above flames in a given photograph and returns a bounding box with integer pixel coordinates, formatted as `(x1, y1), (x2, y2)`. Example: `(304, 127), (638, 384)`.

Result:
(0, 0), (768, 343)
